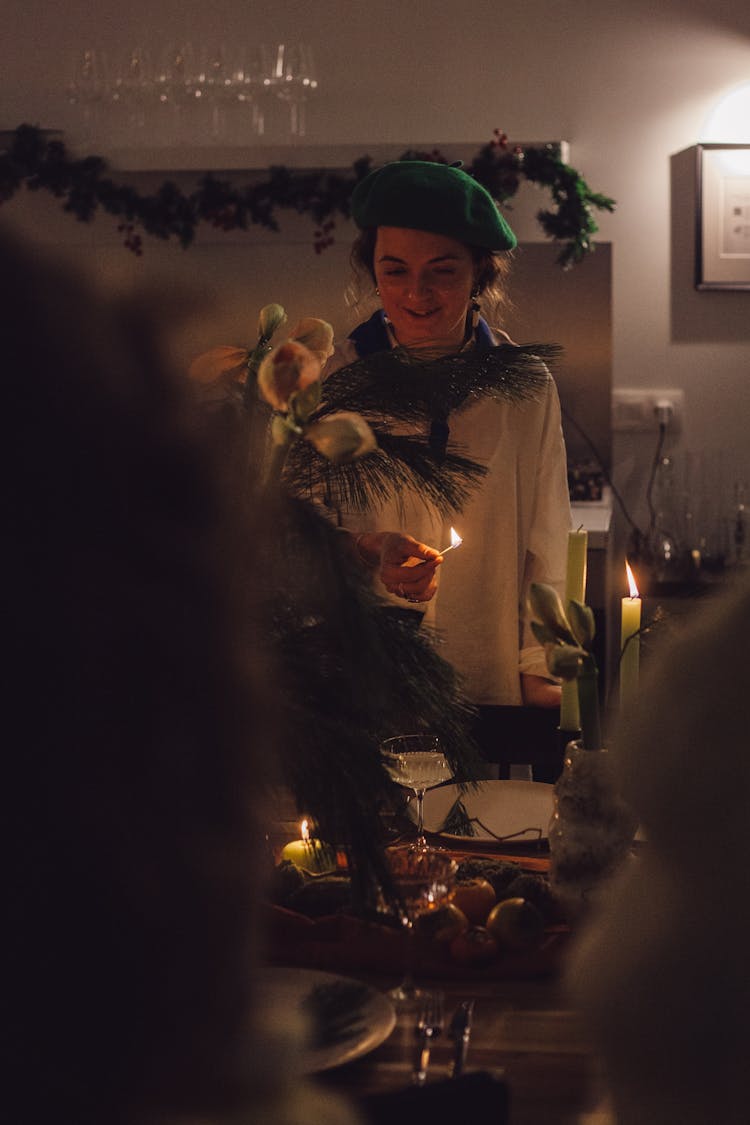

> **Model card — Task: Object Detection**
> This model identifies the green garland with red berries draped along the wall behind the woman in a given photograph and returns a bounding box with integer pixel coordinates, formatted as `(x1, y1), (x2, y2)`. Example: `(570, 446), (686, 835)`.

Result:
(0, 125), (615, 269)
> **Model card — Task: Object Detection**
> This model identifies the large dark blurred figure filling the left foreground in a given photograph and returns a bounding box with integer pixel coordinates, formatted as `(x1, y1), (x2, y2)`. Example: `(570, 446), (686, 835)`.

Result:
(0, 234), (357, 1125)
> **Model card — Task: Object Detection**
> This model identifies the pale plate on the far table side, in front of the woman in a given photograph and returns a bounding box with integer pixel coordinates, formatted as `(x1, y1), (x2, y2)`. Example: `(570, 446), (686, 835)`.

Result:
(420, 781), (554, 844)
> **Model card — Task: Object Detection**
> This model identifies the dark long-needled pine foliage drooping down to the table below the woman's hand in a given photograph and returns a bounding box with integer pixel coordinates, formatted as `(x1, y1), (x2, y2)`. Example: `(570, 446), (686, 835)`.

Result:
(258, 495), (479, 893)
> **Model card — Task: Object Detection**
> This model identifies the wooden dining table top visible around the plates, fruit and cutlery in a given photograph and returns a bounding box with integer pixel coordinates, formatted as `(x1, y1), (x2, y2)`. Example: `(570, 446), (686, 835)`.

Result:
(265, 787), (614, 1125)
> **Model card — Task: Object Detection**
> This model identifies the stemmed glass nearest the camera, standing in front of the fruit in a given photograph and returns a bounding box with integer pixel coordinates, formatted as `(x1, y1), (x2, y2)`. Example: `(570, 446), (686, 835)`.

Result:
(386, 847), (458, 1007)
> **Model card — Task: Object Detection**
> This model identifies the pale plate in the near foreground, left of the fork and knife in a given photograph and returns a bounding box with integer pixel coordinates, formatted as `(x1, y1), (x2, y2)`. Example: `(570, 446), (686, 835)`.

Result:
(259, 965), (396, 1074)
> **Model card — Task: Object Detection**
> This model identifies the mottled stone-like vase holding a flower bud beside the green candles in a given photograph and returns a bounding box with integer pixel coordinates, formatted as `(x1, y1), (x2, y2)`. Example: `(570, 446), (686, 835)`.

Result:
(549, 741), (638, 918)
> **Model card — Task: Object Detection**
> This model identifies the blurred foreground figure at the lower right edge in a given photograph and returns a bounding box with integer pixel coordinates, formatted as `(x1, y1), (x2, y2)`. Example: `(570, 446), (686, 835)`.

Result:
(569, 583), (750, 1125)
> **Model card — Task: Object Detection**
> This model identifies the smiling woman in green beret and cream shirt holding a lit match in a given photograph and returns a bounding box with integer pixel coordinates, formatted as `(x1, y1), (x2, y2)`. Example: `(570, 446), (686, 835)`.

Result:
(326, 161), (570, 733)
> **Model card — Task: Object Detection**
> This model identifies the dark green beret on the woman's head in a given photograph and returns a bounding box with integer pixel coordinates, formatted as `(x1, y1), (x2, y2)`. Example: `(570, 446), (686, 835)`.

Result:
(351, 160), (516, 250)
